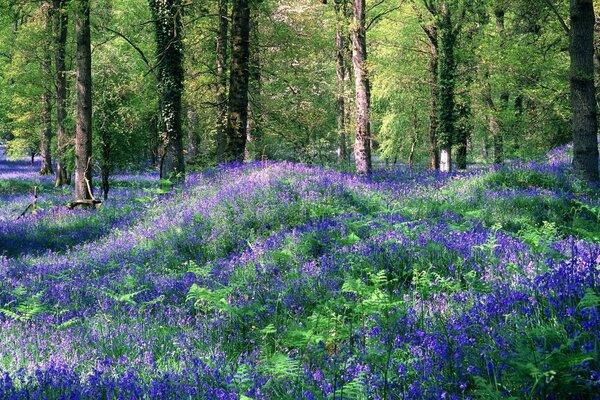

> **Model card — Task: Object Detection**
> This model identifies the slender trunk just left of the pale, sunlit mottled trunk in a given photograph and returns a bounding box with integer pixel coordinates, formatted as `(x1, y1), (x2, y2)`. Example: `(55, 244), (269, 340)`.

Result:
(334, 0), (348, 162)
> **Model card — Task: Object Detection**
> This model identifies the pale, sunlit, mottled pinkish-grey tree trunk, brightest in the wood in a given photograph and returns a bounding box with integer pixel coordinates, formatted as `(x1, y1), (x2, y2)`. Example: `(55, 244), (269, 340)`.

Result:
(351, 0), (372, 175)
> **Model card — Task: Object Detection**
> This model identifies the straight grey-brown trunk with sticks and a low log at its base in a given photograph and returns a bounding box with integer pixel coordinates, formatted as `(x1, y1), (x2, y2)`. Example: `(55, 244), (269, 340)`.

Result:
(75, 0), (93, 200)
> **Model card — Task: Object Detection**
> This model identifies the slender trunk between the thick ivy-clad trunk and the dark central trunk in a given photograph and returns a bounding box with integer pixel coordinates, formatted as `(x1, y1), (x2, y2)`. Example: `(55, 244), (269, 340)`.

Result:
(216, 0), (229, 162)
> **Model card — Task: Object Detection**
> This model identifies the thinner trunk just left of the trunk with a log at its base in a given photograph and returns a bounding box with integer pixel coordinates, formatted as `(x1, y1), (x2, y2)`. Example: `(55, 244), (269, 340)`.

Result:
(52, 0), (70, 186)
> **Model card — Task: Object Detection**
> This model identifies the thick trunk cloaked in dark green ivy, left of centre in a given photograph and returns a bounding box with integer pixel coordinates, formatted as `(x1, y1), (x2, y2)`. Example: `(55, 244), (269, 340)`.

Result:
(149, 0), (185, 179)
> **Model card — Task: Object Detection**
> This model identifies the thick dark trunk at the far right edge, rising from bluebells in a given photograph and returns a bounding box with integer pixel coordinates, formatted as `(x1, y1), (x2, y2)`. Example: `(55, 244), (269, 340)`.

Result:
(569, 0), (598, 182)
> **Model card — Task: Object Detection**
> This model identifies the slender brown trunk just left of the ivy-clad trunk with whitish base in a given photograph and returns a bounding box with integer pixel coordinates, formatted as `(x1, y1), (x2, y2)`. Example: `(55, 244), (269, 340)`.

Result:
(424, 24), (440, 170)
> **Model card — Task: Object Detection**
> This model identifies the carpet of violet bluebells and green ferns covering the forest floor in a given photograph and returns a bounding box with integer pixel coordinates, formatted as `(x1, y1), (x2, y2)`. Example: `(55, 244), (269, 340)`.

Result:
(0, 147), (600, 400)
